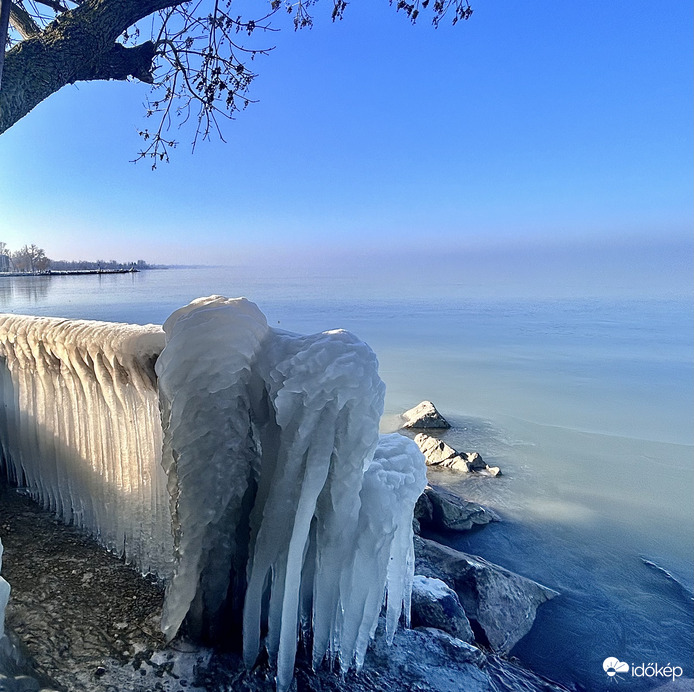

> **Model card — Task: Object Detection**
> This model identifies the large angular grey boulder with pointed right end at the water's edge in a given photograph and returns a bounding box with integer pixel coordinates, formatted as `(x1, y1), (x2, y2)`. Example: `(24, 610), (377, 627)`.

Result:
(414, 536), (558, 653)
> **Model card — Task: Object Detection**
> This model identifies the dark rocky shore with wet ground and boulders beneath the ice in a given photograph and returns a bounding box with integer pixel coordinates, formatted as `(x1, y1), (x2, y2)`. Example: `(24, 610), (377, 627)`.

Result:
(0, 407), (565, 692)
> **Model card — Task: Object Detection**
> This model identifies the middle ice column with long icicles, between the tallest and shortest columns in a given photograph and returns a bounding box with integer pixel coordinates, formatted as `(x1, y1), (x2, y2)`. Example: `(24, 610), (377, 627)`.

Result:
(244, 330), (384, 690)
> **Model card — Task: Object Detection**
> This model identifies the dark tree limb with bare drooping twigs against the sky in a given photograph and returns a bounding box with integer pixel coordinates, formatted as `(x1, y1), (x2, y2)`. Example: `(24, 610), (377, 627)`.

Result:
(0, 0), (472, 166)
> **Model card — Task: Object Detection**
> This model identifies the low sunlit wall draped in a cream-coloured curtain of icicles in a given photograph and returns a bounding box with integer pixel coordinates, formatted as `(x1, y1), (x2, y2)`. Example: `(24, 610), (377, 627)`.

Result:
(0, 315), (172, 577)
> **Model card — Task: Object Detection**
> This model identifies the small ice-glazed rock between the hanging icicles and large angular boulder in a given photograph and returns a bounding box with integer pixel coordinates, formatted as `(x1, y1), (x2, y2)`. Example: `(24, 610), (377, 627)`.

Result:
(411, 575), (475, 643)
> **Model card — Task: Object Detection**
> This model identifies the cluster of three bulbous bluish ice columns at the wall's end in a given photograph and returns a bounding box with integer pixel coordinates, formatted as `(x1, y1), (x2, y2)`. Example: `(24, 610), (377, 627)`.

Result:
(157, 296), (426, 689)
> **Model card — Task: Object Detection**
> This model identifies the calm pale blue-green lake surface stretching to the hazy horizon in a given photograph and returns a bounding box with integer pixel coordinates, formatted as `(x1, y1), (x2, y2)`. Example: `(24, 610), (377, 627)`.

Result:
(0, 268), (694, 690)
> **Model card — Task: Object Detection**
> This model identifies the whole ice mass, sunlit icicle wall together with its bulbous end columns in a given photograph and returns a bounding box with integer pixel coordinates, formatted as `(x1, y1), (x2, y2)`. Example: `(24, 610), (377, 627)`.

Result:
(0, 296), (426, 690)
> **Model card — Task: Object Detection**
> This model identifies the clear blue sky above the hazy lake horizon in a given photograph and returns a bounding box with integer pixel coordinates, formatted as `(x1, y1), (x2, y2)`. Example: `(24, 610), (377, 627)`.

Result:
(0, 0), (693, 290)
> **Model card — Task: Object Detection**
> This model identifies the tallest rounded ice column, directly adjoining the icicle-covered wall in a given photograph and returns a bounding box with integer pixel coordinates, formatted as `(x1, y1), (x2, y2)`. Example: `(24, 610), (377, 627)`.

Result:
(156, 298), (268, 639)
